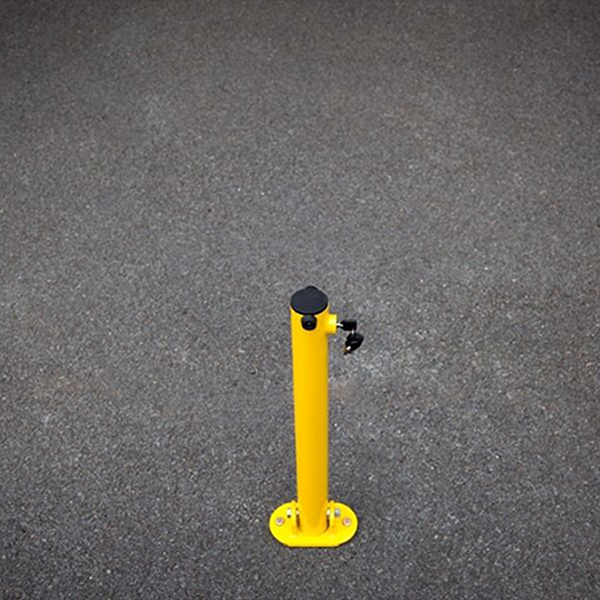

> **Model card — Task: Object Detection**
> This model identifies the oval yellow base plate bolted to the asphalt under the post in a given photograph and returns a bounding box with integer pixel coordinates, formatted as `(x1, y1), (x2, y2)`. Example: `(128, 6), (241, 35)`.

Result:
(269, 502), (358, 548)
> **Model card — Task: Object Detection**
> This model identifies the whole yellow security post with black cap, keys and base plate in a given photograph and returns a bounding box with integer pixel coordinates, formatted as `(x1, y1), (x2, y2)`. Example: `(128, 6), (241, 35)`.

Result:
(269, 286), (363, 547)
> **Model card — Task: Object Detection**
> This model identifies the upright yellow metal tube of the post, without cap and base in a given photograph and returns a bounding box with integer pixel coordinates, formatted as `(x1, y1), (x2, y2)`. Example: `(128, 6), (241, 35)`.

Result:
(290, 307), (337, 535)
